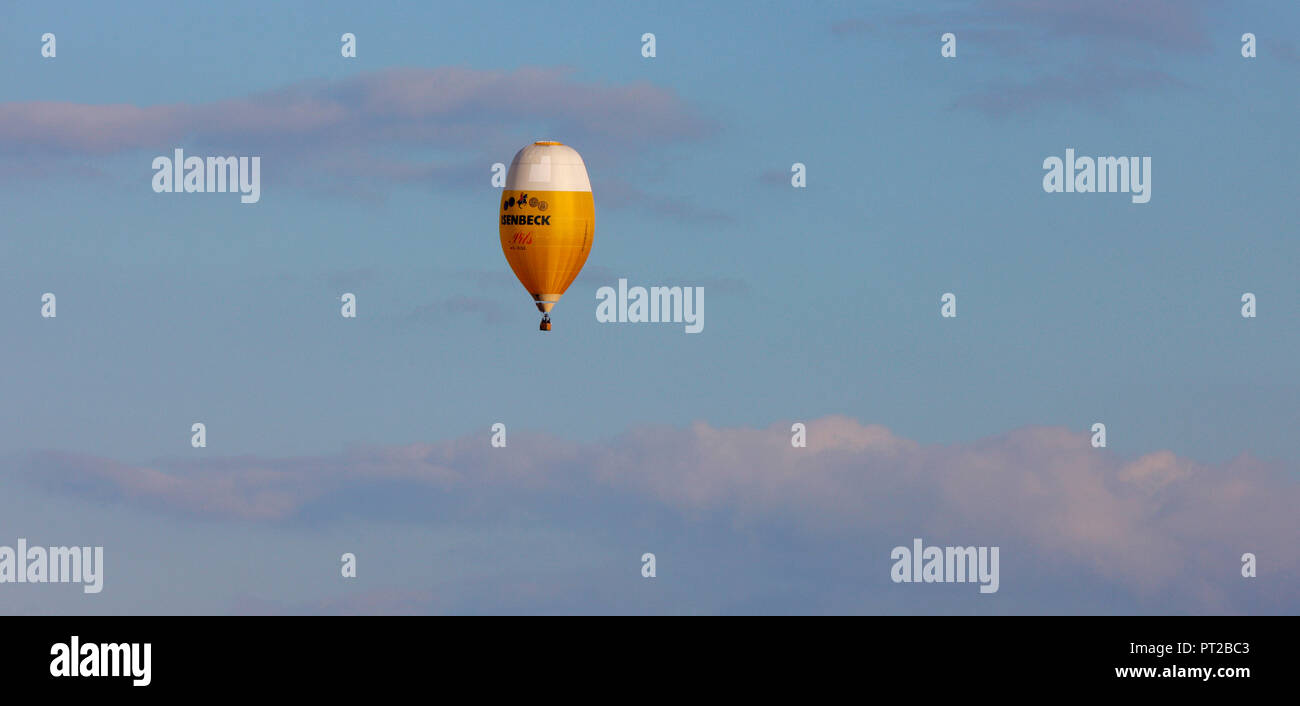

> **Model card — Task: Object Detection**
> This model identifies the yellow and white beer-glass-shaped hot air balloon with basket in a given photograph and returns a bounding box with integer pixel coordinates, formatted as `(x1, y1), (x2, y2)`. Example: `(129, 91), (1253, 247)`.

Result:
(499, 142), (595, 332)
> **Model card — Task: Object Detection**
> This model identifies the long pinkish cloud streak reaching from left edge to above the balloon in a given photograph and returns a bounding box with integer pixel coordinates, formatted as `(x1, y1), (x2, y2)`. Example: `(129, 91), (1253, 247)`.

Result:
(0, 68), (714, 153)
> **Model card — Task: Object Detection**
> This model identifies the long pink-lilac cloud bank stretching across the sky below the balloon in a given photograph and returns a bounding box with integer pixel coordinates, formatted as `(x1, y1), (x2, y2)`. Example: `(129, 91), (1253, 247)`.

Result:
(12, 417), (1300, 610)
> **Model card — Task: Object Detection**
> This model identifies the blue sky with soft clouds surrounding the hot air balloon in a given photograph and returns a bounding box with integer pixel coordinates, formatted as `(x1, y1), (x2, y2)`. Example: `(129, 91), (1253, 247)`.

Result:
(0, 0), (1300, 612)
